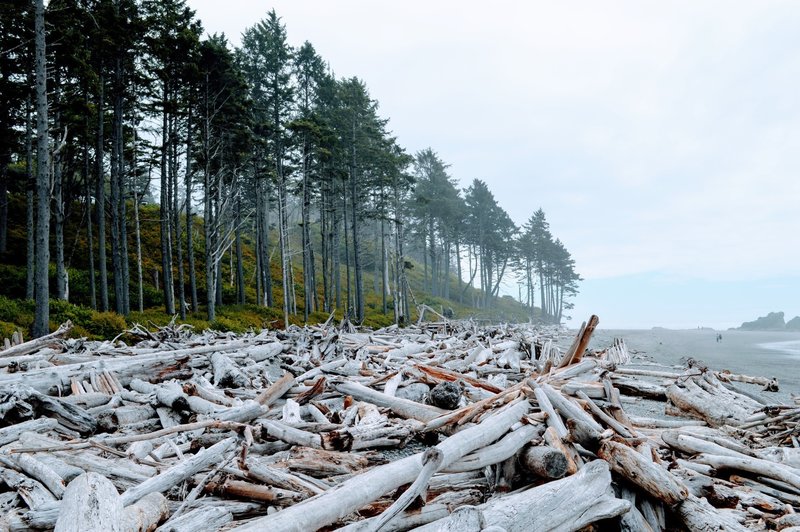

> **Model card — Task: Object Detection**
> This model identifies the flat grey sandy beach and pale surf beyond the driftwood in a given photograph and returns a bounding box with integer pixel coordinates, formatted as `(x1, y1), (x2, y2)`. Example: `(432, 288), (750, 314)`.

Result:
(589, 329), (800, 399)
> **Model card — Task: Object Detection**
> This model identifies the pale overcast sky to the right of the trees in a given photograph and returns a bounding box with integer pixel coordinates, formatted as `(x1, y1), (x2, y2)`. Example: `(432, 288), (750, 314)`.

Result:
(188, 0), (800, 328)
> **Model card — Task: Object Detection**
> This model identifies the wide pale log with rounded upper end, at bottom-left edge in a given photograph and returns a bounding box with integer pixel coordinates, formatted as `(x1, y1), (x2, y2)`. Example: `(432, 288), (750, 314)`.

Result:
(55, 473), (124, 532)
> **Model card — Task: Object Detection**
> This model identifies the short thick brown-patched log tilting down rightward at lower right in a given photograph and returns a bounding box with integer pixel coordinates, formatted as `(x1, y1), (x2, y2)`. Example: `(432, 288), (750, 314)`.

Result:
(598, 441), (688, 505)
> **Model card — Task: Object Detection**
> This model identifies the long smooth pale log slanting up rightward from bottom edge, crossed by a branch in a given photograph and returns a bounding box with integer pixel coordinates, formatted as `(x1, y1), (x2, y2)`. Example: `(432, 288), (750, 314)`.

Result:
(231, 400), (530, 532)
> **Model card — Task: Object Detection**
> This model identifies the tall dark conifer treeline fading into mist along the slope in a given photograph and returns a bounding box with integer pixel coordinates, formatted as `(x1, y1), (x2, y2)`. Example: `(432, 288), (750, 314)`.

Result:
(0, 0), (579, 335)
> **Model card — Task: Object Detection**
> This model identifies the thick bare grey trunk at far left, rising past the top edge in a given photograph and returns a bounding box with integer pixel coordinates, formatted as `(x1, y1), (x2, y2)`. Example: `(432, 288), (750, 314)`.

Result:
(33, 0), (50, 338)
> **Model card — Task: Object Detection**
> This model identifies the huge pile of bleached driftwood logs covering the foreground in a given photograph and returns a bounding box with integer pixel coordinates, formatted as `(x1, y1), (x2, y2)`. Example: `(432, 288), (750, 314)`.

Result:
(0, 317), (800, 532)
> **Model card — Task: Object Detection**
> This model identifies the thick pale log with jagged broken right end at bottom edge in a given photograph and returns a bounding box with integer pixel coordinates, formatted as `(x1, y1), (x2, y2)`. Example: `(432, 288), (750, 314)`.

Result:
(417, 460), (630, 532)
